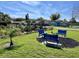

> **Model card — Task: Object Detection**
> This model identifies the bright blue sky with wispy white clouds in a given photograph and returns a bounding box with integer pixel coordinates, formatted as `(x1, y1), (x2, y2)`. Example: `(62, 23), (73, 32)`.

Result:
(0, 1), (79, 21)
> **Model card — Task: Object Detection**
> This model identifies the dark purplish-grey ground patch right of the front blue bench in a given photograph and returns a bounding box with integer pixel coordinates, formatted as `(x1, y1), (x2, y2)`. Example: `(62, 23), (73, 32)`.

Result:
(59, 37), (79, 48)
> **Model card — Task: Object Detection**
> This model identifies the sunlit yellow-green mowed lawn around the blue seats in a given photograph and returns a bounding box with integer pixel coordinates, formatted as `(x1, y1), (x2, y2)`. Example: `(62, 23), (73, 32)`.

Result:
(0, 29), (79, 58)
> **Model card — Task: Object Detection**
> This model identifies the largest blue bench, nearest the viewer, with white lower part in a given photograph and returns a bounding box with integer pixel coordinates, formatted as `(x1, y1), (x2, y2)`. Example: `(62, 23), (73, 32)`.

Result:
(43, 34), (62, 48)
